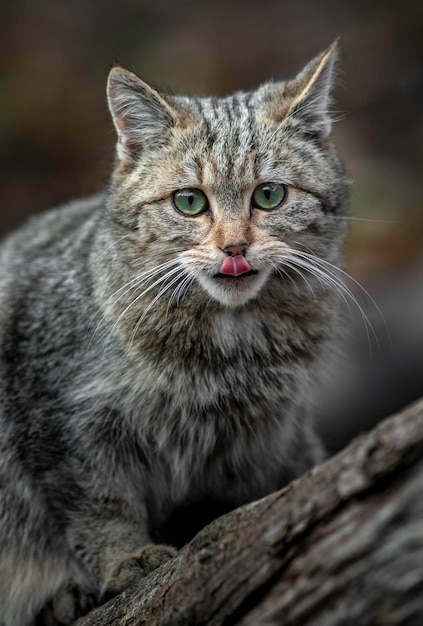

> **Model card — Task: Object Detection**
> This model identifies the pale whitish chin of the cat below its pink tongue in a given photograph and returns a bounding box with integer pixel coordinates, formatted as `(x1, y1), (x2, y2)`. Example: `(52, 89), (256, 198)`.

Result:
(199, 269), (270, 309)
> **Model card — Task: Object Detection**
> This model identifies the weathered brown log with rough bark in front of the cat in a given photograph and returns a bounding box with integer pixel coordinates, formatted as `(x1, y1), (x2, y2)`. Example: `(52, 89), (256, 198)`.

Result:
(77, 401), (423, 626)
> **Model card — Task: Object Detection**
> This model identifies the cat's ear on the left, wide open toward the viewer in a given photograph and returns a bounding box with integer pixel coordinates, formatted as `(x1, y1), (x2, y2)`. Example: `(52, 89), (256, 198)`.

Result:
(107, 67), (178, 159)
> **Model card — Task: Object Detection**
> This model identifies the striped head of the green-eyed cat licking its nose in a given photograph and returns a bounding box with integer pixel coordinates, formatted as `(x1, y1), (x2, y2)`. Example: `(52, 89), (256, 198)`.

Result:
(104, 43), (345, 307)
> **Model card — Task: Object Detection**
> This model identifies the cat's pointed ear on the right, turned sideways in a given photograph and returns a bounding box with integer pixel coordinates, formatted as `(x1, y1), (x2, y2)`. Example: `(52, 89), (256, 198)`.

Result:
(260, 40), (338, 138)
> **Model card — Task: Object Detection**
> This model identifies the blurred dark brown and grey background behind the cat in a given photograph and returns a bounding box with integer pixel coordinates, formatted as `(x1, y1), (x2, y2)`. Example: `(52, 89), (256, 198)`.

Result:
(0, 0), (423, 450)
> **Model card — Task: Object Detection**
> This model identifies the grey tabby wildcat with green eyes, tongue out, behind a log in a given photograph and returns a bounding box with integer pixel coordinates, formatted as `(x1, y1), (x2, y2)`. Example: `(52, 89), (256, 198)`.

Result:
(0, 43), (347, 626)
